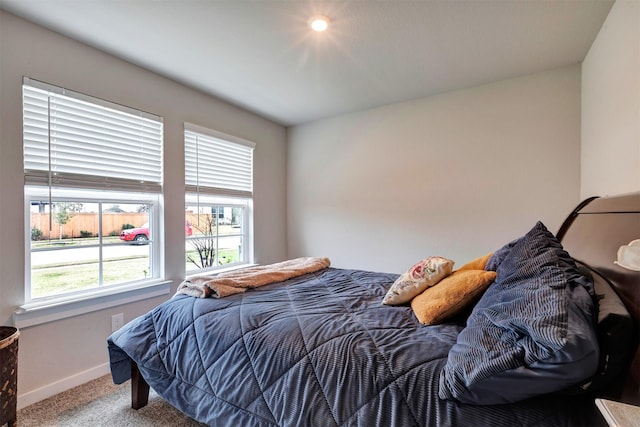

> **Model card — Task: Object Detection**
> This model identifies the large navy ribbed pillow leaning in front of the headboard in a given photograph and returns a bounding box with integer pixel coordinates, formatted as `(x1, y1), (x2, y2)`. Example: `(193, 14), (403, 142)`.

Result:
(439, 222), (598, 405)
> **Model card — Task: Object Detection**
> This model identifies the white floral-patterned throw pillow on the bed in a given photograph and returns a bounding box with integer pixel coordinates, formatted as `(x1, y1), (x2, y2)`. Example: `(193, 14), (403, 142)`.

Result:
(382, 256), (454, 305)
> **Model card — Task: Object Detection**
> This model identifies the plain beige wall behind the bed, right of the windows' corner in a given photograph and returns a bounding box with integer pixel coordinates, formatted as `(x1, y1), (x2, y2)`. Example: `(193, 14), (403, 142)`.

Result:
(287, 65), (580, 272)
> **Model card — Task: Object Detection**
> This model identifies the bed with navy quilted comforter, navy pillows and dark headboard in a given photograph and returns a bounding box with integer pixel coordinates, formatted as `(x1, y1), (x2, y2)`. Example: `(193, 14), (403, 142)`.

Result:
(108, 193), (640, 426)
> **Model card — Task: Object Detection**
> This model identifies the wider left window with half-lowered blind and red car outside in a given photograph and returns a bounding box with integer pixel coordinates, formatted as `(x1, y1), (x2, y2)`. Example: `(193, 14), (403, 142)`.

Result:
(22, 78), (163, 303)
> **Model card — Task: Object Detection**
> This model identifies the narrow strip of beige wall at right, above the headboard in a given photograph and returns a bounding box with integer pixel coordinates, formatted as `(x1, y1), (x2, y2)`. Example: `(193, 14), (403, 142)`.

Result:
(581, 0), (640, 197)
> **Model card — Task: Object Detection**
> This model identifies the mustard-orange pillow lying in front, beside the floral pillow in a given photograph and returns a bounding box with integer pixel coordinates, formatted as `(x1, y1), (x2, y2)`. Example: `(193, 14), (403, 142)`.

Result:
(411, 269), (496, 325)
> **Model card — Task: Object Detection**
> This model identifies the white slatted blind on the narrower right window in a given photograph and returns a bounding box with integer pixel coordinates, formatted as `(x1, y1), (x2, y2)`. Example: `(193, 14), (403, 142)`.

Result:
(184, 123), (255, 197)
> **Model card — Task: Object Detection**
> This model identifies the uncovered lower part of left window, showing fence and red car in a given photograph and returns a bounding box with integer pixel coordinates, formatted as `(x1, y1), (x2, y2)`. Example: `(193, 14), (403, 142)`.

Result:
(26, 191), (160, 300)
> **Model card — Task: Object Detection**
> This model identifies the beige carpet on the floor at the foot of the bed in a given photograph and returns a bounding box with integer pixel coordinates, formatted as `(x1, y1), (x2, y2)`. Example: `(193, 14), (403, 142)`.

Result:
(17, 375), (204, 427)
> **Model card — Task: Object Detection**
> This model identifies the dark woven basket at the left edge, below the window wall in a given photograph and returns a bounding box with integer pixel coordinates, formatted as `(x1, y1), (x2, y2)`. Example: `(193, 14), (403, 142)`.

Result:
(0, 326), (20, 427)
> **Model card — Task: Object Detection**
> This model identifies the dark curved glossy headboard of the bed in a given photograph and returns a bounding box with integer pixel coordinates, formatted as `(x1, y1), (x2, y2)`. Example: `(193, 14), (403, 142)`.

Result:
(557, 192), (640, 405)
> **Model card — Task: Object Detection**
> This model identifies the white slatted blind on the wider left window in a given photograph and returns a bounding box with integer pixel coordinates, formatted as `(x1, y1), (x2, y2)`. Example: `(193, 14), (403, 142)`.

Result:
(22, 78), (163, 193)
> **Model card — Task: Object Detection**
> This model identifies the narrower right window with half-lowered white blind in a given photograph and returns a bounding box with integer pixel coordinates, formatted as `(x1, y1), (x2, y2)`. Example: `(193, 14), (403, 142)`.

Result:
(184, 123), (255, 273)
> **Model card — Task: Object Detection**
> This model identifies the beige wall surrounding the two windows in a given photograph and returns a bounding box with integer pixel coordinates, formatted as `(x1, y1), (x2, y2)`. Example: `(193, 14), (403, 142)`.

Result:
(0, 11), (286, 403)
